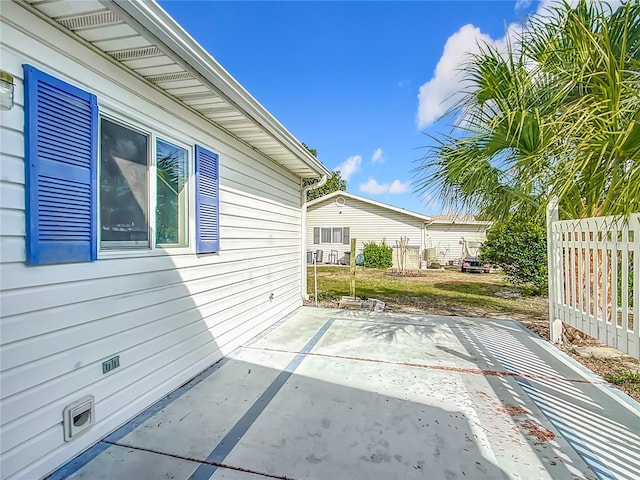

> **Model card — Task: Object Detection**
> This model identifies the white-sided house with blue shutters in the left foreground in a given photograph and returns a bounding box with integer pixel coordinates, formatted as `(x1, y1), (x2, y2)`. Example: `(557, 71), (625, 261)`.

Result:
(0, 0), (330, 479)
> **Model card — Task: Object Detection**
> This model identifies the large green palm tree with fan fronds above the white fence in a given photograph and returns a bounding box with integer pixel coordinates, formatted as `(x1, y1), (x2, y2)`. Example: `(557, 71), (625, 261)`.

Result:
(416, 0), (640, 219)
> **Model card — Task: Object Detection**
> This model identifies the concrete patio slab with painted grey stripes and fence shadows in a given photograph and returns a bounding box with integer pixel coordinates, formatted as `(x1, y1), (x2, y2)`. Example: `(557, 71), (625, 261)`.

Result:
(51, 308), (640, 480)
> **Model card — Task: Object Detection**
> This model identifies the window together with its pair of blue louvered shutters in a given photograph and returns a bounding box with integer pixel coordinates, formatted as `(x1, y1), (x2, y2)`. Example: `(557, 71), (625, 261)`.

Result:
(23, 64), (220, 265)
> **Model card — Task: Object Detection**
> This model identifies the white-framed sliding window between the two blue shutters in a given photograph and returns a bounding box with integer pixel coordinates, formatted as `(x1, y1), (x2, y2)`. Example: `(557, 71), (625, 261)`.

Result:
(99, 116), (191, 251)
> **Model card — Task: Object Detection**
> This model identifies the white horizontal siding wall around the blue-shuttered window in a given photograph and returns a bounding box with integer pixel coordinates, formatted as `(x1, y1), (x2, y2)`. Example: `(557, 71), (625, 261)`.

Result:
(0, 3), (301, 479)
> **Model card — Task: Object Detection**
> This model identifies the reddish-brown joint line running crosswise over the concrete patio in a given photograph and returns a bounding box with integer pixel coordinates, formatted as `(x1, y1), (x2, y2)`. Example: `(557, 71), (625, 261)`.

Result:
(240, 346), (606, 385)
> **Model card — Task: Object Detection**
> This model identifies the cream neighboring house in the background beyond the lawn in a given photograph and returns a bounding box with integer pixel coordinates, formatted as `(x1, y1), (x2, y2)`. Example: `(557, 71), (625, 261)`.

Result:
(306, 191), (491, 268)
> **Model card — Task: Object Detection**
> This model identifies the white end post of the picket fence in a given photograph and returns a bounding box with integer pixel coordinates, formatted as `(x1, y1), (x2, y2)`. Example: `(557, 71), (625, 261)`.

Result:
(547, 197), (562, 343)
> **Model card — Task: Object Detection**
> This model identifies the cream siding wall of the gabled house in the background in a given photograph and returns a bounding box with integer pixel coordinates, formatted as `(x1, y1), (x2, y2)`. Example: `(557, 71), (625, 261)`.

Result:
(307, 197), (424, 262)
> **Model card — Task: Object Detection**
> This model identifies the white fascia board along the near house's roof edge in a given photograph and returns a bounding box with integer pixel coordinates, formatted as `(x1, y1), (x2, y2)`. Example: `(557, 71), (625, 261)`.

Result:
(99, 0), (331, 177)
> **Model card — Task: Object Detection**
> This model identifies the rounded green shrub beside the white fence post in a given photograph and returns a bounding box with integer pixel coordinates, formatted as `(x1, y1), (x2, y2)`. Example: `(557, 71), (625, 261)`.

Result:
(480, 216), (548, 294)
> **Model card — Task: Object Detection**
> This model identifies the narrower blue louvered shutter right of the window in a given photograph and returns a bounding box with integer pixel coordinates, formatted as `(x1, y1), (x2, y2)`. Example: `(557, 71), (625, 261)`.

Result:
(195, 145), (220, 253)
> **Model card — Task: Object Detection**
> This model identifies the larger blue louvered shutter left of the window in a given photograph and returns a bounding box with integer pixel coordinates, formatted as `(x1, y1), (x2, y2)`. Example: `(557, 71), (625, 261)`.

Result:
(23, 65), (98, 265)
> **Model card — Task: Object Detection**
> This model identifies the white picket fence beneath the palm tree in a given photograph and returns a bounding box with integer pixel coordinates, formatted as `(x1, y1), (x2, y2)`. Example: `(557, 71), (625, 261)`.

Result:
(547, 205), (640, 359)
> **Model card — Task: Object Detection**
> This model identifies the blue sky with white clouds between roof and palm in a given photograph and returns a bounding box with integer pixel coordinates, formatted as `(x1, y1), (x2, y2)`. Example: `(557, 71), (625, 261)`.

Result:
(160, 0), (544, 214)
